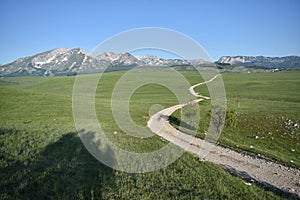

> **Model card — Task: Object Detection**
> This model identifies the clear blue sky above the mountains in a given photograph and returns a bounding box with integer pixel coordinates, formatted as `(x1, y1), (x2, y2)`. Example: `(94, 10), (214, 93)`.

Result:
(0, 0), (300, 64)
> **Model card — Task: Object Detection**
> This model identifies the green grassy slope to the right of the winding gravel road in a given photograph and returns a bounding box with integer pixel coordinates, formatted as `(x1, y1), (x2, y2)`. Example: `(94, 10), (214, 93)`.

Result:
(173, 72), (300, 168)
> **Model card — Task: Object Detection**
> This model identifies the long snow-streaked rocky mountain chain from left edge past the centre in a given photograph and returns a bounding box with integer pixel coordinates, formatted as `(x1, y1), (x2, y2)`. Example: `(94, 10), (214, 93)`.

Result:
(0, 48), (205, 77)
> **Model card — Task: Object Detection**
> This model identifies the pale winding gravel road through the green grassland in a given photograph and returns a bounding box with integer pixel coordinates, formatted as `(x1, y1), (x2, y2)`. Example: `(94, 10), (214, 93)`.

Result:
(147, 75), (300, 198)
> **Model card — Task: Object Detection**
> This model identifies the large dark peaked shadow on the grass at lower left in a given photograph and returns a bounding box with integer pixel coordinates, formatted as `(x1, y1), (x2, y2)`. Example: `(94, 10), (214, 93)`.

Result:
(0, 132), (115, 199)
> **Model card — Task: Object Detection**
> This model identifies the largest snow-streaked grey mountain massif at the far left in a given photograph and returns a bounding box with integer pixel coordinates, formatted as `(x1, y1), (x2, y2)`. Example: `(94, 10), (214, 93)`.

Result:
(0, 48), (110, 76)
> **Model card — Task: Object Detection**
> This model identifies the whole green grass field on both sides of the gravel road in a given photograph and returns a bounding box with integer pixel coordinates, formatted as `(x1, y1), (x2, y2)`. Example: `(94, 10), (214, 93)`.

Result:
(0, 71), (300, 199)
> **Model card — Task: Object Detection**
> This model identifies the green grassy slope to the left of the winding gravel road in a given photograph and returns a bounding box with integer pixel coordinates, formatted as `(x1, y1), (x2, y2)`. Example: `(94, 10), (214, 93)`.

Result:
(0, 72), (296, 199)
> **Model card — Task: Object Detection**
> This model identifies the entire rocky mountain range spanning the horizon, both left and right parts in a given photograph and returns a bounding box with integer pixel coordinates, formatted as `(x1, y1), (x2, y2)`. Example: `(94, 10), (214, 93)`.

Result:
(0, 48), (300, 77)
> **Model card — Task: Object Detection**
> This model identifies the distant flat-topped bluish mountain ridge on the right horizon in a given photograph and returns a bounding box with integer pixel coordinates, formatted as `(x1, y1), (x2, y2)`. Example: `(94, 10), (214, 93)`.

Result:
(218, 56), (300, 68)
